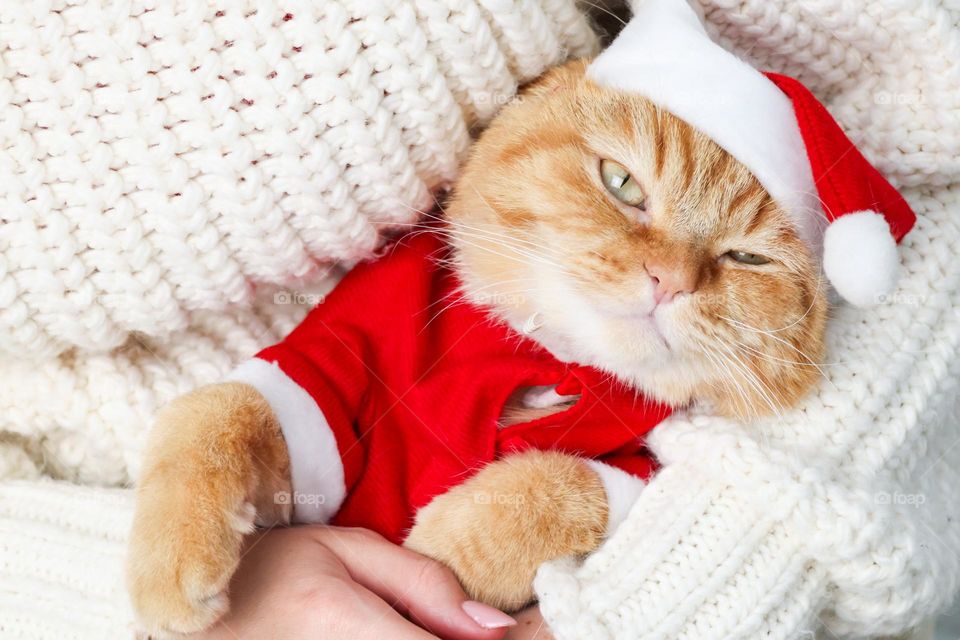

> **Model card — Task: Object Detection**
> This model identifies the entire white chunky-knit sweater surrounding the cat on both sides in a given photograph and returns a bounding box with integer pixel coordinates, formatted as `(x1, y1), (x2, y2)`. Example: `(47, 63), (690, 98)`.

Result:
(0, 0), (960, 640)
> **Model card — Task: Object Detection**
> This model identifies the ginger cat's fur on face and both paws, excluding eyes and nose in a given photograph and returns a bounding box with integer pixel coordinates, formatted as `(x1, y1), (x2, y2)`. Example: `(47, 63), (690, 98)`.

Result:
(129, 61), (826, 631)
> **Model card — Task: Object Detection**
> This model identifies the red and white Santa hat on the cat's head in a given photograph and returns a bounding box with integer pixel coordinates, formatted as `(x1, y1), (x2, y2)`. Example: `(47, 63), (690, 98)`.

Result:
(587, 0), (916, 306)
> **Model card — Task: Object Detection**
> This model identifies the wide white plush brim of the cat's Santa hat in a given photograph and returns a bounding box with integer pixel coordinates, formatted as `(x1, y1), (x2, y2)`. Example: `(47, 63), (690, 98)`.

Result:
(587, 0), (823, 255)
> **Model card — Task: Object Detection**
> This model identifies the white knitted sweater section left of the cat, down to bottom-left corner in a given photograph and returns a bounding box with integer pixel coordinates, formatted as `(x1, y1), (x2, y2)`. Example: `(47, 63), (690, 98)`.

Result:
(0, 0), (597, 640)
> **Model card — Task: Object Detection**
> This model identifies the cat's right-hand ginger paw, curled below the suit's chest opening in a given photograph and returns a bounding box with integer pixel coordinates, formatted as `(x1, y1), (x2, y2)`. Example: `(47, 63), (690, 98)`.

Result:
(404, 451), (607, 611)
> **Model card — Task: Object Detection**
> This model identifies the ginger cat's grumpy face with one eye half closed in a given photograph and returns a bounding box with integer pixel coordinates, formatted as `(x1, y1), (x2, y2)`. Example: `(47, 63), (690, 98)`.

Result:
(447, 62), (825, 417)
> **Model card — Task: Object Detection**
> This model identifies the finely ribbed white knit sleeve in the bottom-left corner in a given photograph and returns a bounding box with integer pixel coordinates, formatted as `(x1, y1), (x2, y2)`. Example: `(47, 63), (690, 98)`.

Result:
(0, 481), (134, 640)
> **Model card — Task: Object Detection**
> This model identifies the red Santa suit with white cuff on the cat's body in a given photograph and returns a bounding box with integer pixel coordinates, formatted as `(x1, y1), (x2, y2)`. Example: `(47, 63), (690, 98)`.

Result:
(231, 234), (670, 542)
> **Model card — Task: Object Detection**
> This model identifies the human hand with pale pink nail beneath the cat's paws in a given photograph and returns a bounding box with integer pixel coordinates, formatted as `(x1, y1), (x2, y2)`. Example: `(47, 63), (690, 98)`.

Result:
(190, 526), (515, 640)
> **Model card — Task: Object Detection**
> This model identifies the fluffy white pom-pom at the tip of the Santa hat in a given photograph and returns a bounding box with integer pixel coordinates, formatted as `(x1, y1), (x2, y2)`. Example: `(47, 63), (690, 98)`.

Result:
(823, 211), (900, 307)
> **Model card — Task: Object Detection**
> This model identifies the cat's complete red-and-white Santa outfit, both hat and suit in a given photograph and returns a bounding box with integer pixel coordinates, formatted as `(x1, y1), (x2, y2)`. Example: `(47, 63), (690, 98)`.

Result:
(223, 0), (916, 540)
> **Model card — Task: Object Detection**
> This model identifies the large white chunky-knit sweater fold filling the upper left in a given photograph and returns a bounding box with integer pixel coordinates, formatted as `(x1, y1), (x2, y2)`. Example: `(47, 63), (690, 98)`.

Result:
(0, 0), (596, 359)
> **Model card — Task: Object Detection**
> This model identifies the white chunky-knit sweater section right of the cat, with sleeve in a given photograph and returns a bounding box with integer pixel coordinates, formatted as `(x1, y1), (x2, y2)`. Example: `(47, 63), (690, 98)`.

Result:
(536, 0), (960, 640)
